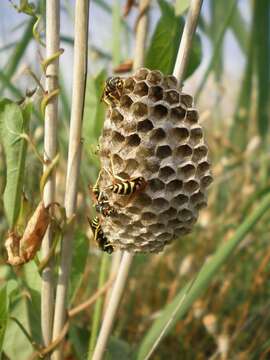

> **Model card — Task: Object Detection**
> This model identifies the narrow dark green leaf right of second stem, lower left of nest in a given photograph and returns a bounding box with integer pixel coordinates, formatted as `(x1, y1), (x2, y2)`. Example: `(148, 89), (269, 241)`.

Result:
(69, 233), (89, 303)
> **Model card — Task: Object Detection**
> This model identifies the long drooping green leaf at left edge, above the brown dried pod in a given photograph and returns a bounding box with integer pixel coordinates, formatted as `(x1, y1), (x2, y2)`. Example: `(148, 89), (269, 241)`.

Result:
(0, 99), (32, 229)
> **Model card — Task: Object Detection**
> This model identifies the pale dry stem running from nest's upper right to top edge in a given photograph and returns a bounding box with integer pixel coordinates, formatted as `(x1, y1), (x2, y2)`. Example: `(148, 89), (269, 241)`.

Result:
(173, 0), (203, 87)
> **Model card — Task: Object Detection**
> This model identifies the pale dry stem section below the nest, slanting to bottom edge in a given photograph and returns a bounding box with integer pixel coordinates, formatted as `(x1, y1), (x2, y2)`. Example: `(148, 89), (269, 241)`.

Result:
(92, 252), (133, 360)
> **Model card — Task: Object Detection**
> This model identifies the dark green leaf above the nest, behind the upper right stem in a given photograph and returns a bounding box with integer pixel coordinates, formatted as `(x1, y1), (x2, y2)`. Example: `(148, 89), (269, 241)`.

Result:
(145, 0), (201, 77)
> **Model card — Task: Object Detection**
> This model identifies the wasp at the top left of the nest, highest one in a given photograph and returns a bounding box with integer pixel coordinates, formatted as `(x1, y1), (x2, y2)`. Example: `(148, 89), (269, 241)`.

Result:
(101, 76), (124, 107)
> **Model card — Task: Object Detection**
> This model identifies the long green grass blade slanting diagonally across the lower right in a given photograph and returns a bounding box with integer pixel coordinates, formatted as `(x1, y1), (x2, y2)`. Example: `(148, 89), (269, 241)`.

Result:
(137, 194), (270, 360)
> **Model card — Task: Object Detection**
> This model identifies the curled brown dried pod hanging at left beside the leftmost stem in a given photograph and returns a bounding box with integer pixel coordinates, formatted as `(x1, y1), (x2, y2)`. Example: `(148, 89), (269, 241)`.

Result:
(5, 201), (50, 266)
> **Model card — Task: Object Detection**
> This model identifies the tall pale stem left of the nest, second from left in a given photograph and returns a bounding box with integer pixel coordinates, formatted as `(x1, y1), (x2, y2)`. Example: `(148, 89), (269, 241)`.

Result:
(52, 0), (89, 360)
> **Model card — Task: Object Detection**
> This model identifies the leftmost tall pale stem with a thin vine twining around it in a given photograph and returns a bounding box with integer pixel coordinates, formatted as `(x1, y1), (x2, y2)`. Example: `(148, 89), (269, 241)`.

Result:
(41, 0), (60, 346)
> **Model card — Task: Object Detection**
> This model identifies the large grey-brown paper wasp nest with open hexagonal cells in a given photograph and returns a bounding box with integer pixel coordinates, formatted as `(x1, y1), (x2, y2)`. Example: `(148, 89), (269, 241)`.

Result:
(100, 68), (212, 252)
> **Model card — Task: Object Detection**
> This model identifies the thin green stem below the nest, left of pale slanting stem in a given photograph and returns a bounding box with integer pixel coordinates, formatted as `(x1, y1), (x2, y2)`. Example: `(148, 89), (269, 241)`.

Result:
(88, 253), (109, 360)
